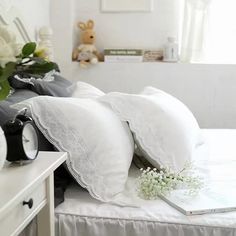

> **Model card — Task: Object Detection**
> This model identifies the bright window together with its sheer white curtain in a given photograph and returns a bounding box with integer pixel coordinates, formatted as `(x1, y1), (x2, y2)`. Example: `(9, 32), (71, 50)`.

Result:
(180, 0), (236, 64)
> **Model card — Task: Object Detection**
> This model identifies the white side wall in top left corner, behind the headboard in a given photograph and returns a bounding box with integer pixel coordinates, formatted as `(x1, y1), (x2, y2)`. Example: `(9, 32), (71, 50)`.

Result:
(0, 0), (50, 40)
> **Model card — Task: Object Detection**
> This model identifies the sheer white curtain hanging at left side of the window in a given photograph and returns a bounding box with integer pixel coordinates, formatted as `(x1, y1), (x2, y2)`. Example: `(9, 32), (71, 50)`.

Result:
(180, 0), (211, 62)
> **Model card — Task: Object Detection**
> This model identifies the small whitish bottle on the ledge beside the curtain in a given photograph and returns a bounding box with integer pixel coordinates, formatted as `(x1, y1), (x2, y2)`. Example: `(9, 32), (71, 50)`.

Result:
(163, 37), (179, 62)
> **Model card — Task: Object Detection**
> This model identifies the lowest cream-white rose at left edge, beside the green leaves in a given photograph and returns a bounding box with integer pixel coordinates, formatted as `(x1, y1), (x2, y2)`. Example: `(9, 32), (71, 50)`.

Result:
(0, 37), (16, 67)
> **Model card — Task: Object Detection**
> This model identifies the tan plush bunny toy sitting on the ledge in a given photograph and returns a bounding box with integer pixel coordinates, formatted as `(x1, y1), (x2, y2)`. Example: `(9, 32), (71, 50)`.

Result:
(72, 20), (99, 67)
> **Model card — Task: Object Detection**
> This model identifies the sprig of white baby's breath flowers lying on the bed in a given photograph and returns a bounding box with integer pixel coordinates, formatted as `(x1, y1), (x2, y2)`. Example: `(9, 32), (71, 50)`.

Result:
(137, 163), (203, 200)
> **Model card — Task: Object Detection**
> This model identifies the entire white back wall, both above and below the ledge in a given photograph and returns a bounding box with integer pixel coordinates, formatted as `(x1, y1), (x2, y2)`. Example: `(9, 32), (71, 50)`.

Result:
(51, 0), (236, 128)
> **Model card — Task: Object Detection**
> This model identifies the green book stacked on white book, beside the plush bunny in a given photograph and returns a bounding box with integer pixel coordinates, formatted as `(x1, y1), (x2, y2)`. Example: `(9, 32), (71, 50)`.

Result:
(104, 49), (143, 62)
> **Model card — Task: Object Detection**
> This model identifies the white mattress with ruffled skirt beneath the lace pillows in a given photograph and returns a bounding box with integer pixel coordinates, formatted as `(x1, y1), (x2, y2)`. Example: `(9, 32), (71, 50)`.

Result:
(55, 130), (236, 236)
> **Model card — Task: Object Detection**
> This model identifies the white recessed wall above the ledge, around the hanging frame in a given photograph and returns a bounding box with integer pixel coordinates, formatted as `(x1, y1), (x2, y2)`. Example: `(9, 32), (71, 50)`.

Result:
(74, 0), (180, 50)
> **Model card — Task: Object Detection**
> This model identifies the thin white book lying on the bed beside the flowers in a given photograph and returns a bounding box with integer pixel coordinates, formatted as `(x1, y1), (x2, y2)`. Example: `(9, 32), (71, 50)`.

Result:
(161, 189), (236, 215)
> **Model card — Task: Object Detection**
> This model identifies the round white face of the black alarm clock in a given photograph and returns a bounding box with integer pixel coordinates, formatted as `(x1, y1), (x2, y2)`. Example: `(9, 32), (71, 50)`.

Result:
(22, 123), (38, 160)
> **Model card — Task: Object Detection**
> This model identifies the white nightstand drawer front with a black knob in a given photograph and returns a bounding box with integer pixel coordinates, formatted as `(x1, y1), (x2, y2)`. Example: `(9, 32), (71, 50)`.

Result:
(0, 181), (47, 236)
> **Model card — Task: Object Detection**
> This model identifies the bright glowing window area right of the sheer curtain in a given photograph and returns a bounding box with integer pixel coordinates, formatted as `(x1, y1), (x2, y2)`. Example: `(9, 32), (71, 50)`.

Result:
(203, 0), (236, 64)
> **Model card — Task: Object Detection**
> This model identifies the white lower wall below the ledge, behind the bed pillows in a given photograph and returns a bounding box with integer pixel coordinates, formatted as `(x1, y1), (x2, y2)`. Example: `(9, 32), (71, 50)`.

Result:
(71, 62), (236, 128)
